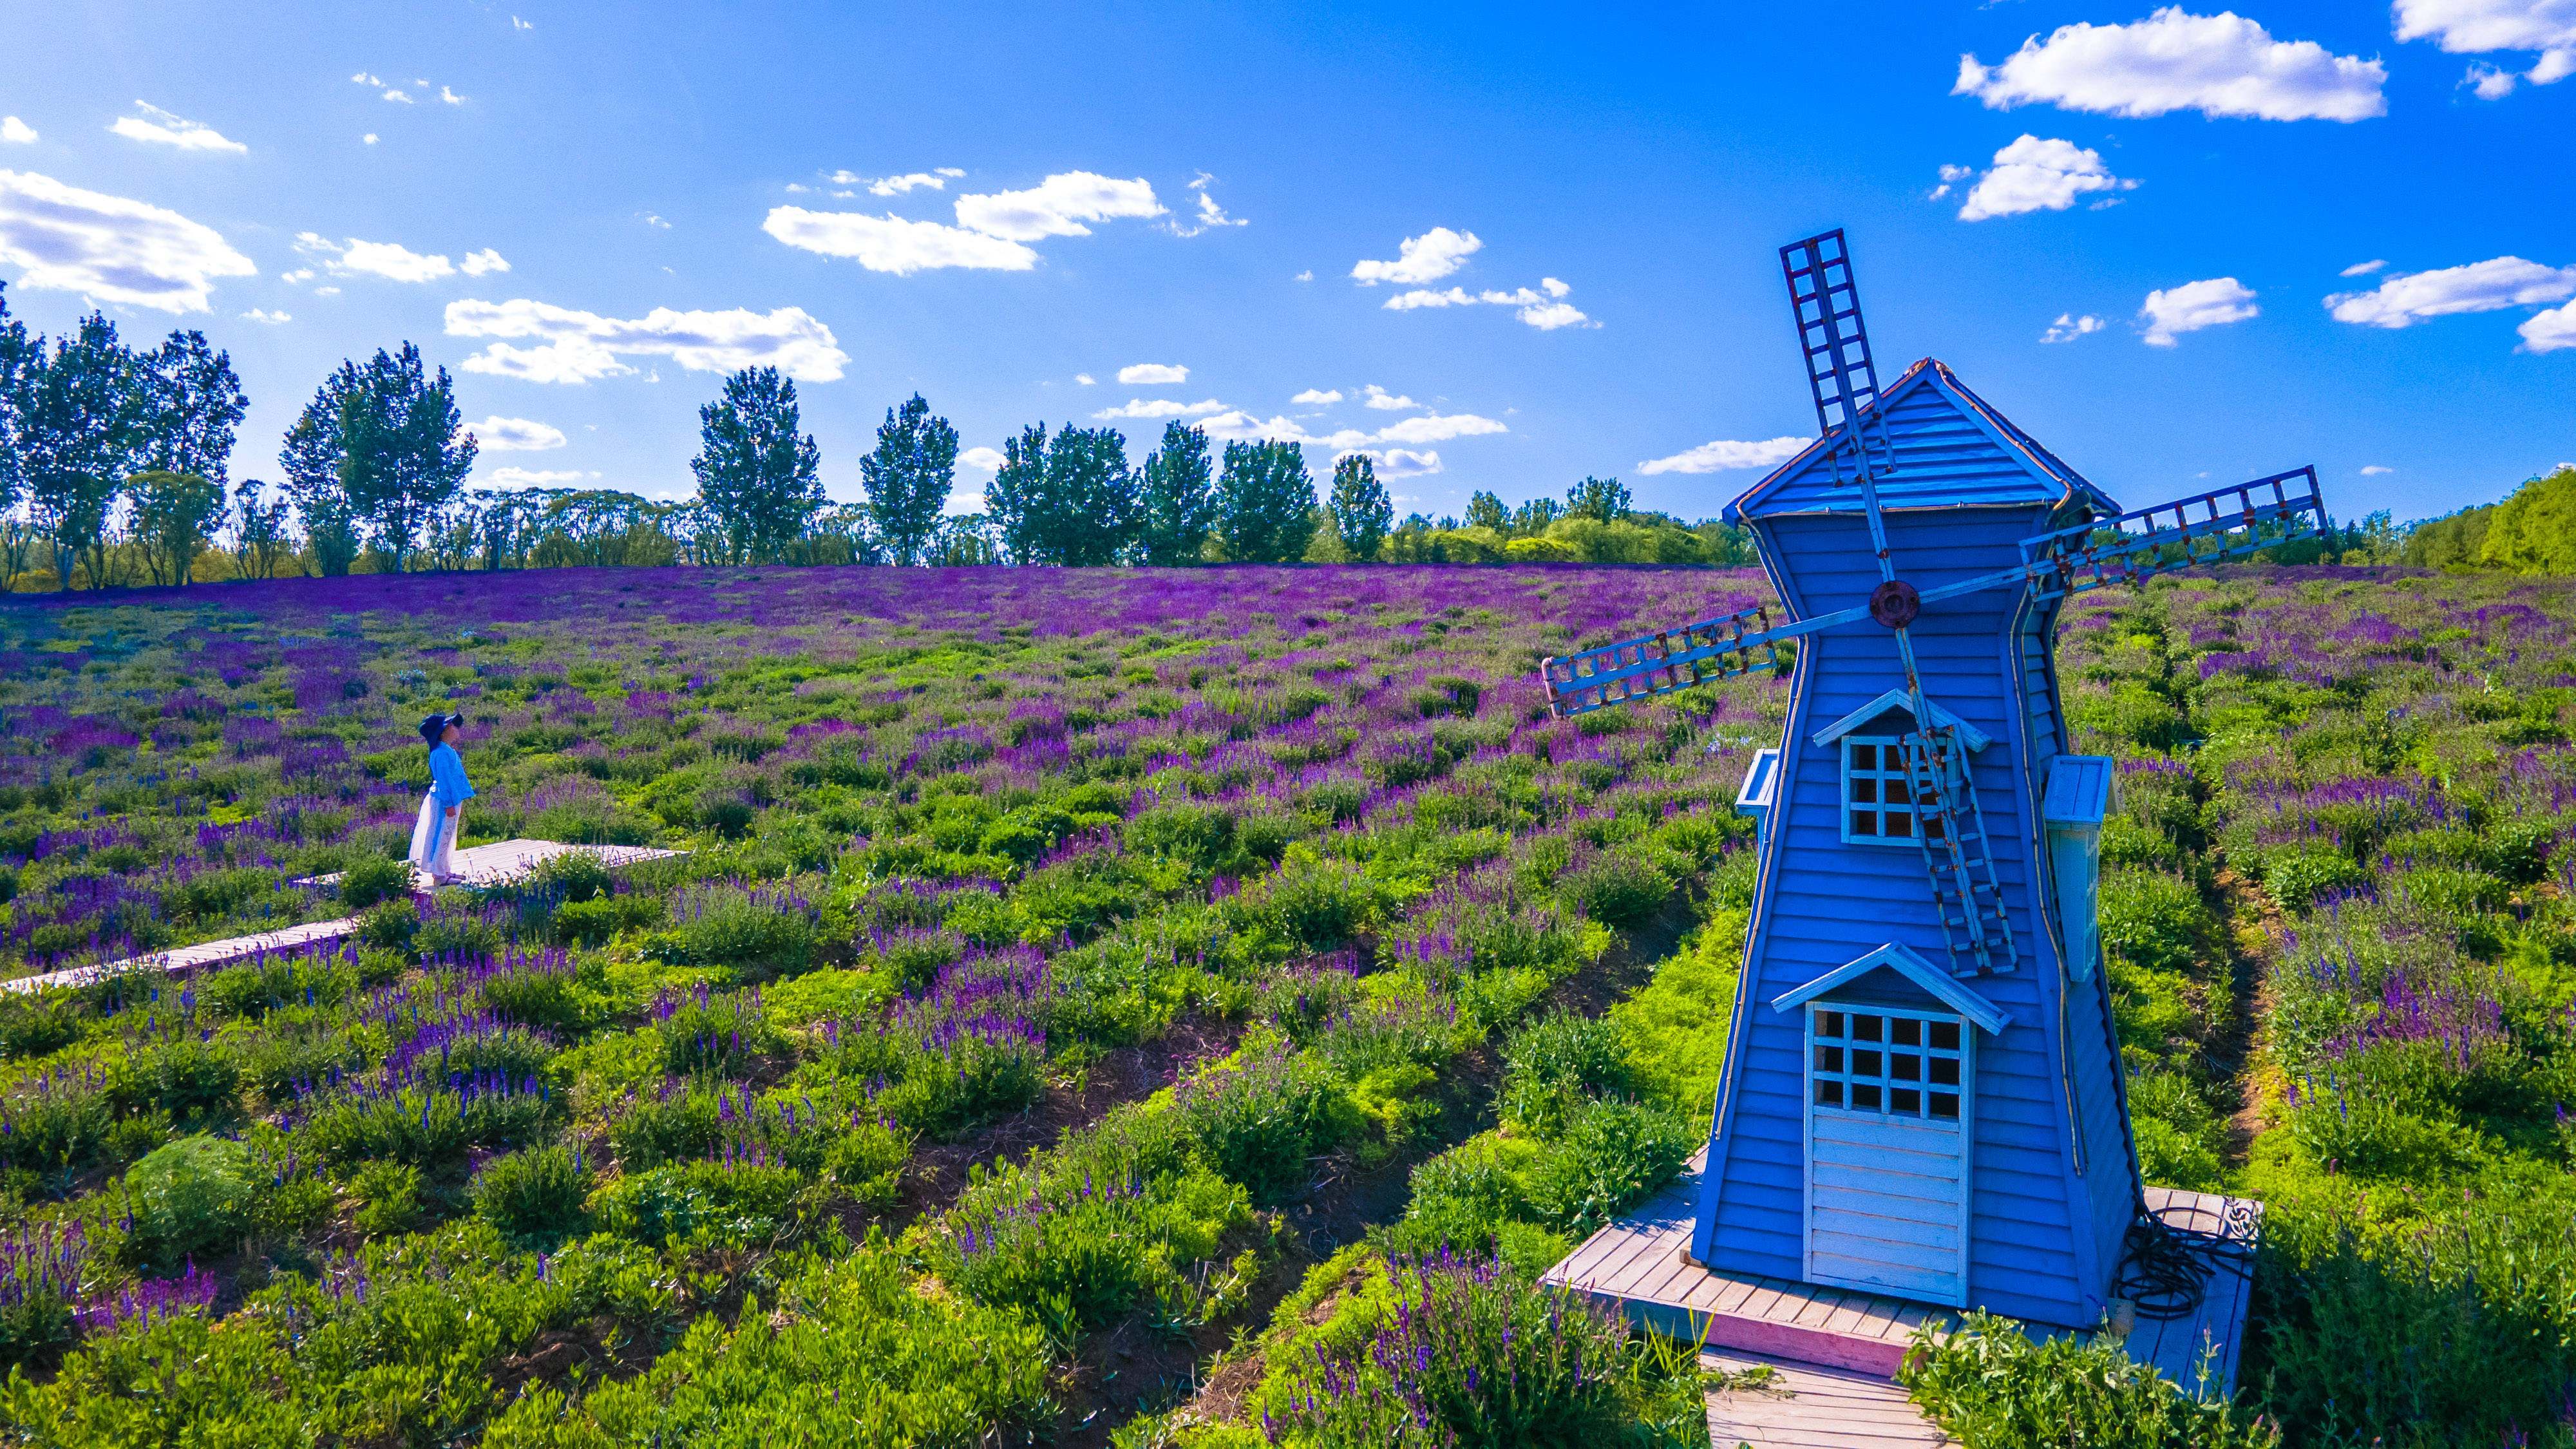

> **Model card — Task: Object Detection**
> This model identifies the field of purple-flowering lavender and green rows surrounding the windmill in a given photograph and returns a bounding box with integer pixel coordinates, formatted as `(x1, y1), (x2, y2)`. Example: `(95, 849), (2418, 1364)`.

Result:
(0, 567), (2576, 1449)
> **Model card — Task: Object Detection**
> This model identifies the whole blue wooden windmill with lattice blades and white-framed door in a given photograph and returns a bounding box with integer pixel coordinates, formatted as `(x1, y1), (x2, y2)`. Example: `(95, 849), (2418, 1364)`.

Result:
(1543, 232), (2324, 1325)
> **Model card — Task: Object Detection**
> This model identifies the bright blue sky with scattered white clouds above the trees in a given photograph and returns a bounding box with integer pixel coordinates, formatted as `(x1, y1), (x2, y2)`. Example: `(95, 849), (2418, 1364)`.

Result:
(0, 0), (2576, 518)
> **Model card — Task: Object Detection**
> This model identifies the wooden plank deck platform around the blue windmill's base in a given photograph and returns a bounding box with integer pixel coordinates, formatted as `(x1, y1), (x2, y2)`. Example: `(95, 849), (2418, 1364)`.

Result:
(1543, 1150), (2262, 1449)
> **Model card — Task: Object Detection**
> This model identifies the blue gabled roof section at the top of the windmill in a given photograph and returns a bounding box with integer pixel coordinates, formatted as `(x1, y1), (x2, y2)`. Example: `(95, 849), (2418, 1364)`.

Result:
(1726, 358), (2120, 524)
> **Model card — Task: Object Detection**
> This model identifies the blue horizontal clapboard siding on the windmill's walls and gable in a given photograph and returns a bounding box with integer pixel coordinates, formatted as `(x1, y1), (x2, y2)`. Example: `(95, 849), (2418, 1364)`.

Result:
(1692, 379), (2138, 1325)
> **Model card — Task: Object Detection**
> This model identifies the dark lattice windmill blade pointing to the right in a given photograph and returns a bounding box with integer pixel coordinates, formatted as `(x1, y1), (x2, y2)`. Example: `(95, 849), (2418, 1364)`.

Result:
(2020, 464), (2326, 598)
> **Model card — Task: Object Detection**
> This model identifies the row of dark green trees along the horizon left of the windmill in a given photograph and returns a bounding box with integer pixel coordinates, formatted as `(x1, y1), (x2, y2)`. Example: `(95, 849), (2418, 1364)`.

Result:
(0, 296), (1752, 591)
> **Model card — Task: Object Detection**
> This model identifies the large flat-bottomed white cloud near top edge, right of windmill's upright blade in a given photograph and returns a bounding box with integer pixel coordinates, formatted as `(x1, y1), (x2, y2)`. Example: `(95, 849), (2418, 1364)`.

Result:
(1950, 5), (2388, 121)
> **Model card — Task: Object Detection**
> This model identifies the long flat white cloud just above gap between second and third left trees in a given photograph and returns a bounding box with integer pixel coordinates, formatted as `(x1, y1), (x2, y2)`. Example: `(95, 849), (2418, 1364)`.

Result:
(446, 299), (850, 382)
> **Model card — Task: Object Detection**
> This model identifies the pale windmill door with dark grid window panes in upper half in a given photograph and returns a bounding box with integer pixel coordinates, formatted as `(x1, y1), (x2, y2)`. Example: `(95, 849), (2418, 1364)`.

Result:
(1806, 1000), (1976, 1307)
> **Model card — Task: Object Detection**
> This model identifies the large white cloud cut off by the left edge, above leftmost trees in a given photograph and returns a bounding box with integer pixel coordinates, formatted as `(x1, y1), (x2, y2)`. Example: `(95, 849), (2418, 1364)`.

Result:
(0, 170), (260, 312)
